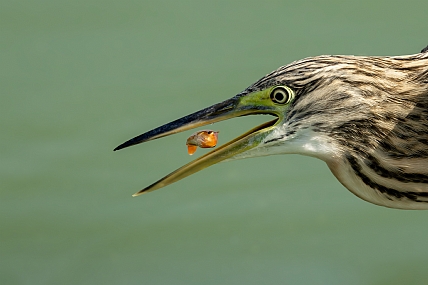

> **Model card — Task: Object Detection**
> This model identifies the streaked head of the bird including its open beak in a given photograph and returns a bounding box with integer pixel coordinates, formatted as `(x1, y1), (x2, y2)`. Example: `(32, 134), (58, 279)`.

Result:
(115, 53), (428, 196)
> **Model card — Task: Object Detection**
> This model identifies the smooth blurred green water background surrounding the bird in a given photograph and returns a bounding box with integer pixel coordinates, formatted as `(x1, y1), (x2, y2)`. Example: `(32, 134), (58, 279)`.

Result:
(0, 0), (428, 284)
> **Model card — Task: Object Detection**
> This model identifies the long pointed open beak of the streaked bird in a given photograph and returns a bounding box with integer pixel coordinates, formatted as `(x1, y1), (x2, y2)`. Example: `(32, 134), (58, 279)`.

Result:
(114, 93), (280, 196)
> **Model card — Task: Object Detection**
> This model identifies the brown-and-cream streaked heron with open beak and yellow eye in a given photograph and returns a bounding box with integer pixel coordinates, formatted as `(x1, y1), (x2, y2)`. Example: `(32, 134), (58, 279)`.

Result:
(114, 46), (428, 210)
